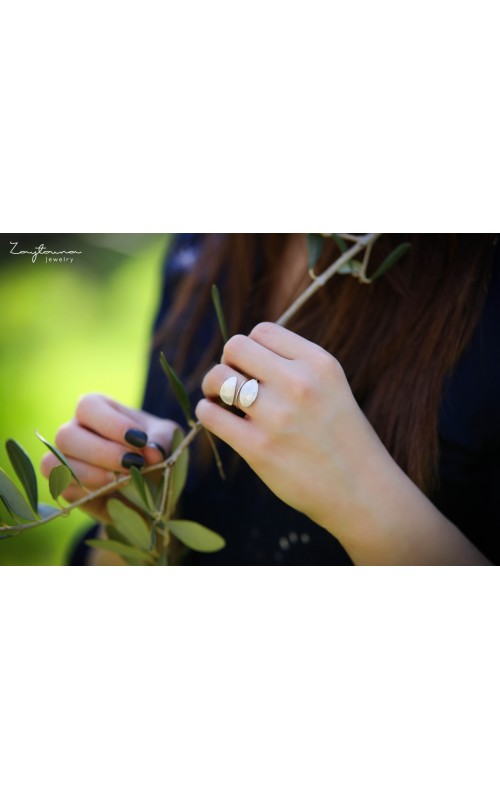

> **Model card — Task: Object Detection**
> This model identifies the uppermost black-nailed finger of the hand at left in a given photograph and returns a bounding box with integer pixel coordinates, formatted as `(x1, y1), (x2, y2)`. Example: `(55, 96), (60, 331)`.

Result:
(75, 394), (148, 448)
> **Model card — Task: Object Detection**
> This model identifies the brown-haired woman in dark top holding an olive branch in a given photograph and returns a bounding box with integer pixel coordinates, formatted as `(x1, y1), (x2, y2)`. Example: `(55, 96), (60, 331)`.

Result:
(42, 234), (500, 565)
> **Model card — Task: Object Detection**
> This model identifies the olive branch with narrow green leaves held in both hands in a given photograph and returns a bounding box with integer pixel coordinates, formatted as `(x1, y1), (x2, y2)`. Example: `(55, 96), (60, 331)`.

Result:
(0, 233), (410, 566)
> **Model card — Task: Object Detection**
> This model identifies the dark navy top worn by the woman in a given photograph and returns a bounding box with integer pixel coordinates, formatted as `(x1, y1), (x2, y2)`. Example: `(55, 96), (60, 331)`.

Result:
(72, 234), (500, 566)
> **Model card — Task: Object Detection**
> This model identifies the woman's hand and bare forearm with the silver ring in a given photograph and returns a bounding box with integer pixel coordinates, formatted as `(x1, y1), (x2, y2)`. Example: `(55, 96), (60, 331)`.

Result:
(196, 323), (492, 564)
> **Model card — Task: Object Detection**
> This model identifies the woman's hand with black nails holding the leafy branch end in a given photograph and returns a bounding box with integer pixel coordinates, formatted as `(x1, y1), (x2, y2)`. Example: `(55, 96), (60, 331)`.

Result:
(41, 394), (178, 522)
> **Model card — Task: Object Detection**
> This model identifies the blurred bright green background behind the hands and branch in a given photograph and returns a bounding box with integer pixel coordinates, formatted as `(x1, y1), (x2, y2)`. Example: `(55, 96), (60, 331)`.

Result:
(0, 234), (169, 565)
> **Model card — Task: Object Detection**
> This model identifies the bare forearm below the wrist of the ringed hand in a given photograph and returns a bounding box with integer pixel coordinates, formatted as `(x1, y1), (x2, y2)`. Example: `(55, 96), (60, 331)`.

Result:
(324, 462), (491, 566)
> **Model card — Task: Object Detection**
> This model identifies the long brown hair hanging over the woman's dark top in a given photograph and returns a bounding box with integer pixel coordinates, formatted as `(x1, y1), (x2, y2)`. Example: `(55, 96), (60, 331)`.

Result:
(156, 234), (495, 493)
